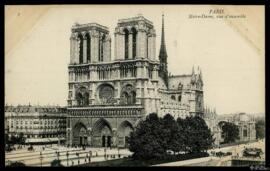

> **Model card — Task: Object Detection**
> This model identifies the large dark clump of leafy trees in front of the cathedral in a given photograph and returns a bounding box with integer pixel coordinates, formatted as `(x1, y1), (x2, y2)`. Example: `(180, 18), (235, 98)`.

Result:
(128, 113), (214, 159)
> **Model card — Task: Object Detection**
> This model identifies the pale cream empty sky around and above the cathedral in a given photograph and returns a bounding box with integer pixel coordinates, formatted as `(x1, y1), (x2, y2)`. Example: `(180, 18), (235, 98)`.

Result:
(5, 5), (265, 114)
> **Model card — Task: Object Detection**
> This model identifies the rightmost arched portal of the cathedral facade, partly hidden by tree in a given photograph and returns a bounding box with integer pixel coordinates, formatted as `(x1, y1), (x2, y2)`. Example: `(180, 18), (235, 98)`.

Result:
(118, 121), (133, 147)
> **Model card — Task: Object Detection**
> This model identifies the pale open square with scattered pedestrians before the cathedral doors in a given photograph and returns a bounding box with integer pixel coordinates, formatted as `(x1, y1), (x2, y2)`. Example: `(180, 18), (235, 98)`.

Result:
(5, 145), (131, 167)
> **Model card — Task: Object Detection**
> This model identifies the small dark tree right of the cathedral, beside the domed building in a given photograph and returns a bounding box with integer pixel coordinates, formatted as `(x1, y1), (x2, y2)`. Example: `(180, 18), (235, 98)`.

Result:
(218, 121), (239, 144)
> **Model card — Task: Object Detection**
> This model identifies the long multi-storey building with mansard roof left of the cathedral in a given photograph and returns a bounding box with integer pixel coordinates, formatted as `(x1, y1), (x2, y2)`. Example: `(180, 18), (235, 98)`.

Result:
(5, 105), (66, 144)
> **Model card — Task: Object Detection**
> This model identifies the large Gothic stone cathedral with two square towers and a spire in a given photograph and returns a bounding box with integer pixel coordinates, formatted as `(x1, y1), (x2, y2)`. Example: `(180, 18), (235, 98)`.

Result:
(67, 15), (204, 147)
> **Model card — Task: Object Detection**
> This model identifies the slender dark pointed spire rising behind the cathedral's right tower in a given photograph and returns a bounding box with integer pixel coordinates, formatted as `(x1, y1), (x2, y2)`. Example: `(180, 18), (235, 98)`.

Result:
(158, 14), (169, 88)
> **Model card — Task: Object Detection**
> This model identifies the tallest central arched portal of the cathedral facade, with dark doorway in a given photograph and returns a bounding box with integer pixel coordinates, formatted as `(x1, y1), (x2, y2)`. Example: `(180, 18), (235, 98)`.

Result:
(93, 118), (113, 147)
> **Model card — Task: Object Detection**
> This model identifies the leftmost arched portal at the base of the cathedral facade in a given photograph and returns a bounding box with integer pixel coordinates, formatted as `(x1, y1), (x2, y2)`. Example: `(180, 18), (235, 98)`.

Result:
(73, 122), (88, 146)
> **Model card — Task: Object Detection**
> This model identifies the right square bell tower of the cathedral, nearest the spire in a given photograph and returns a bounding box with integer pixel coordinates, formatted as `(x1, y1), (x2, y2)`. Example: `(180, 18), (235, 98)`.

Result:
(114, 15), (156, 60)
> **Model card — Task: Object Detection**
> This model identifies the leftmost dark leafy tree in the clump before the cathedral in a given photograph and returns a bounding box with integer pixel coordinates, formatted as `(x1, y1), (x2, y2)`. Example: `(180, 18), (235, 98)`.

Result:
(128, 113), (166, 159)
